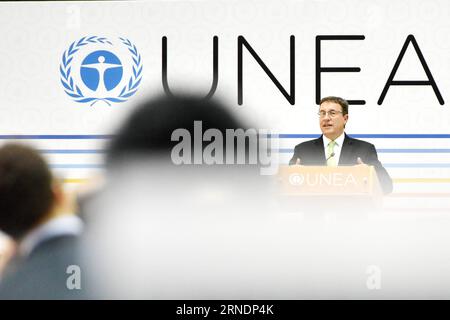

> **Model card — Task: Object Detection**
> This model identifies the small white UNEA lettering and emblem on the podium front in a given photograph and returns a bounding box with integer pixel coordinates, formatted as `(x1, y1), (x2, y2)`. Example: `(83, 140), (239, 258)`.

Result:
(289, 172), (358, 187)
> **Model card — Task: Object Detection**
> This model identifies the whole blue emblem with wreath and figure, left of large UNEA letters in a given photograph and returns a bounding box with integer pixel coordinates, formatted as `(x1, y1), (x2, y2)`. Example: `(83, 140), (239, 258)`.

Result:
(59, 36), (142, 106)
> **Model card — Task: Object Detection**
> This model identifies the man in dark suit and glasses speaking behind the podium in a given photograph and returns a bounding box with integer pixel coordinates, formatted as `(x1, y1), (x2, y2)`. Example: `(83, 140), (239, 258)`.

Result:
(289, 97), (392, 194)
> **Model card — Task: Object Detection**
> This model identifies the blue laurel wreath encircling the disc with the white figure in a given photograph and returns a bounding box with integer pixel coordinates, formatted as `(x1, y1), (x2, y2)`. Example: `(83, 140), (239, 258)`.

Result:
(59, 36), (142, 106)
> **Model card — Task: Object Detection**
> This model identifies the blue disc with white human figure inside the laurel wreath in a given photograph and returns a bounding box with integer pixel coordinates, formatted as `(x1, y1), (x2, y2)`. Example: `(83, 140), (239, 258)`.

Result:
(80, 50), (123, 94)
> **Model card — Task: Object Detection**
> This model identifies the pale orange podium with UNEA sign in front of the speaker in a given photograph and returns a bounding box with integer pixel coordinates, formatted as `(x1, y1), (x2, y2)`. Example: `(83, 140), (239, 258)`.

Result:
(278, 165), (382, 213)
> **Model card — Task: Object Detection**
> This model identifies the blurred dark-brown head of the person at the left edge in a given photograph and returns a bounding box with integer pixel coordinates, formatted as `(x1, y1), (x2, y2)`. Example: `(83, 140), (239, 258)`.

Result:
(0, 143), (54, 239)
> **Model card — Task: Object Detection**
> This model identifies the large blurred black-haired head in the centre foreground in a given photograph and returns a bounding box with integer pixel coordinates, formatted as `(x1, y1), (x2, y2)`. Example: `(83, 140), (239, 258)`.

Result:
(107, 96), (244, 165)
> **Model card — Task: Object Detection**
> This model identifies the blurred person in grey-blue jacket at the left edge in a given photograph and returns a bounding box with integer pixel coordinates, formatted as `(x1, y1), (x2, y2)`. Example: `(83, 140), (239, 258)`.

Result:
(0, 143), (83, 299)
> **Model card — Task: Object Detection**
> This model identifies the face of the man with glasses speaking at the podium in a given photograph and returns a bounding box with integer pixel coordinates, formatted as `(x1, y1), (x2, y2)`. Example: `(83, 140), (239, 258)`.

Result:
(319, 101), (348, 140)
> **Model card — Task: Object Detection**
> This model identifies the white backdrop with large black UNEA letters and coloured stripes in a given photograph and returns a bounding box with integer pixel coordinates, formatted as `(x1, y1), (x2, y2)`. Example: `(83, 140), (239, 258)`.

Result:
(0, 0), (450, 209)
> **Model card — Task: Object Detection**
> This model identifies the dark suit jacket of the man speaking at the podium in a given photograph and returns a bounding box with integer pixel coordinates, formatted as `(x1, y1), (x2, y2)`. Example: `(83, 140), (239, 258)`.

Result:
(289, 134), (392, 193)
